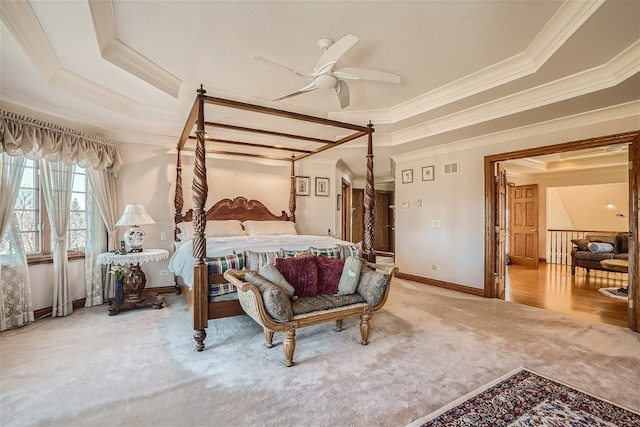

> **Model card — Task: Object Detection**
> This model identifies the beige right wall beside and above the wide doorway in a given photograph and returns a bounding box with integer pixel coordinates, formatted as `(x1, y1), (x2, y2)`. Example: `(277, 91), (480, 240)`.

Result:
(394, 115), (638, 288)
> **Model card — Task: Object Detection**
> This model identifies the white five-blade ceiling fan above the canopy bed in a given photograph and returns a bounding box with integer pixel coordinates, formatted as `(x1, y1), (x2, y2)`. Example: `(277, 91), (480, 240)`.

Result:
(256, 34), (400, 108)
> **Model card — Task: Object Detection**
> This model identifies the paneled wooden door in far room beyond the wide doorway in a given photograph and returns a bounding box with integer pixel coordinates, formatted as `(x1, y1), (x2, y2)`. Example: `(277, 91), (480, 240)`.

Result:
(509, 184), (538, 269)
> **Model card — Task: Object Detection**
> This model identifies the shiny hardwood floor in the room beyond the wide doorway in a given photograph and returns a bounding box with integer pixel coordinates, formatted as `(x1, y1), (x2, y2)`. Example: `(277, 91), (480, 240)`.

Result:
(505, 263), (628, 327)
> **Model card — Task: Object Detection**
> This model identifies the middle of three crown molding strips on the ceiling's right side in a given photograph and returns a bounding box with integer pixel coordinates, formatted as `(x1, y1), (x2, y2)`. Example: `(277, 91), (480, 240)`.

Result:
(392, 40), (640, 145)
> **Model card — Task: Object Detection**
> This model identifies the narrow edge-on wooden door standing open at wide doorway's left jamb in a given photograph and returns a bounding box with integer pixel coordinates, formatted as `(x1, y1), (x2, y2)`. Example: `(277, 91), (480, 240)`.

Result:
(494, 163), (507, 299)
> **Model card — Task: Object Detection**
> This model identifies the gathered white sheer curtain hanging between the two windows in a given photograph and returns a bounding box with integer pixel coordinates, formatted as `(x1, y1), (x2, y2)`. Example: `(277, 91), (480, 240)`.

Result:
(38, 159), (73, 317)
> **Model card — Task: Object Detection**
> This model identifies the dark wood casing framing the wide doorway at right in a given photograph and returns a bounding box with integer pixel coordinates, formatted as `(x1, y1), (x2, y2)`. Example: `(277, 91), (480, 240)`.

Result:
(484, 131), (640, 332)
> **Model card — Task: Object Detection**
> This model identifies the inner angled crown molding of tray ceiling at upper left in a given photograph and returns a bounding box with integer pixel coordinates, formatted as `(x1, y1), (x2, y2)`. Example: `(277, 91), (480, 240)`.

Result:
(89, 0), (182, 98)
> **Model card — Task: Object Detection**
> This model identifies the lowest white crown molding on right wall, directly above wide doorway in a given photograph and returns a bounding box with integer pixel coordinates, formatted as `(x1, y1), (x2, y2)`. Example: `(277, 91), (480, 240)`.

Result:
(391, 101), (640, 162)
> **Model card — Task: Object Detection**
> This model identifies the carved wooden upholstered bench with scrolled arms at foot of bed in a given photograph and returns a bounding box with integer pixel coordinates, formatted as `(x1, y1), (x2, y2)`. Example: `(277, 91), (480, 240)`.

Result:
(224, 260), (397, 366)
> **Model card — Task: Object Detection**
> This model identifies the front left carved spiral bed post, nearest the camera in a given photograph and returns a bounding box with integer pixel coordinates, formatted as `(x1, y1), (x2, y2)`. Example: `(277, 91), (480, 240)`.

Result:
(192, 85), (209, 351)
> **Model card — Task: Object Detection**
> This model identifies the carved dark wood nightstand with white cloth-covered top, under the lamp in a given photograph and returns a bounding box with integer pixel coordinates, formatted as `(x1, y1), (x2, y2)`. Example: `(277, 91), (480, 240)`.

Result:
(97, 249), (169, 316)
